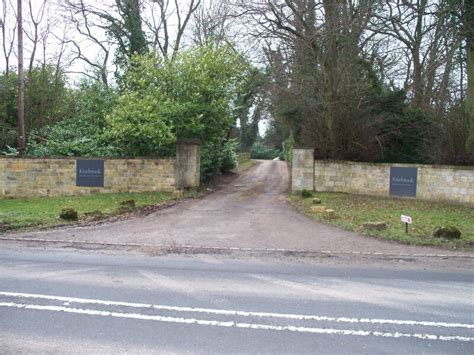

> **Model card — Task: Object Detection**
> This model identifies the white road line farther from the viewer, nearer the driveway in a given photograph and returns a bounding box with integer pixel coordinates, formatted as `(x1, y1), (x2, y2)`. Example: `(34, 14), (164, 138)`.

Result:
(0, 292), (474, 329)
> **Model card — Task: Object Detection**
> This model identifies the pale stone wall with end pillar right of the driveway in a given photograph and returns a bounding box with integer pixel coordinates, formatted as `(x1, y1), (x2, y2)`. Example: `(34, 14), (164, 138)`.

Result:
(292, 149), (474, 204)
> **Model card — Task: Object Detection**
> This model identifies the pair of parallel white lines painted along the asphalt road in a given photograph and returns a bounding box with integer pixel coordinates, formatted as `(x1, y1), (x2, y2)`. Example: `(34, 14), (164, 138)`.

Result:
(0, 292), (474, 342)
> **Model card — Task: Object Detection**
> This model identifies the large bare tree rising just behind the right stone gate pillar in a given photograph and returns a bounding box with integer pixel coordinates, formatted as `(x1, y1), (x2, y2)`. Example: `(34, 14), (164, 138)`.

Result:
(231, 0), (376, 158)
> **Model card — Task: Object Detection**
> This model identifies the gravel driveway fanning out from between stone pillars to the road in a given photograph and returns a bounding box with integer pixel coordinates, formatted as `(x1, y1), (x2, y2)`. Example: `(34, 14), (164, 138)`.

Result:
(1, 161), (472, 262)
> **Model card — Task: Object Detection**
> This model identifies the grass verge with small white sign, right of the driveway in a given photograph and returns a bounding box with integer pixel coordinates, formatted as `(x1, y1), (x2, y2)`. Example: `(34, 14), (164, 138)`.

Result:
(291, 192), (474, 251)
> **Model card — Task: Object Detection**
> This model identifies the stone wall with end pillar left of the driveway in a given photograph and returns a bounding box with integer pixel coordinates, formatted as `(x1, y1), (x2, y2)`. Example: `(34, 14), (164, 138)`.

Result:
(0, 144), (199, 198)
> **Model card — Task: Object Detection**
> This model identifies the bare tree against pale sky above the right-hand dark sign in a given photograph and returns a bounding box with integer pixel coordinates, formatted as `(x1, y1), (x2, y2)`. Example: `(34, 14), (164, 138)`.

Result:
(370, 0), (460, 109)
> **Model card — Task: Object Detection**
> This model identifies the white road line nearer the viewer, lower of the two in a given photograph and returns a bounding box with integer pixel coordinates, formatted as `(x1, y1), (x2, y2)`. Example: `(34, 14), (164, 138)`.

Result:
(0, 302), (474, 342)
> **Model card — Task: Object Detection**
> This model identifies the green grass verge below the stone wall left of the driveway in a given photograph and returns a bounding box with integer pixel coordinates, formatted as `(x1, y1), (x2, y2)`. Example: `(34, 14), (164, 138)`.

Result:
(0, 192), (193, 231)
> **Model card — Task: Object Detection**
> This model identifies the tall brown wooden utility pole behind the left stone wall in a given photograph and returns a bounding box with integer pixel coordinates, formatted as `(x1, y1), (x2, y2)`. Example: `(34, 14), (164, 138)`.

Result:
(17, 0), (25, 157)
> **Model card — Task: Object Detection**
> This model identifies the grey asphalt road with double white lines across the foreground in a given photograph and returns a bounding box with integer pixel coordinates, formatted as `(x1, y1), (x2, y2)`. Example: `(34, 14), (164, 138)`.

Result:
(0, 246), (474, 354)
